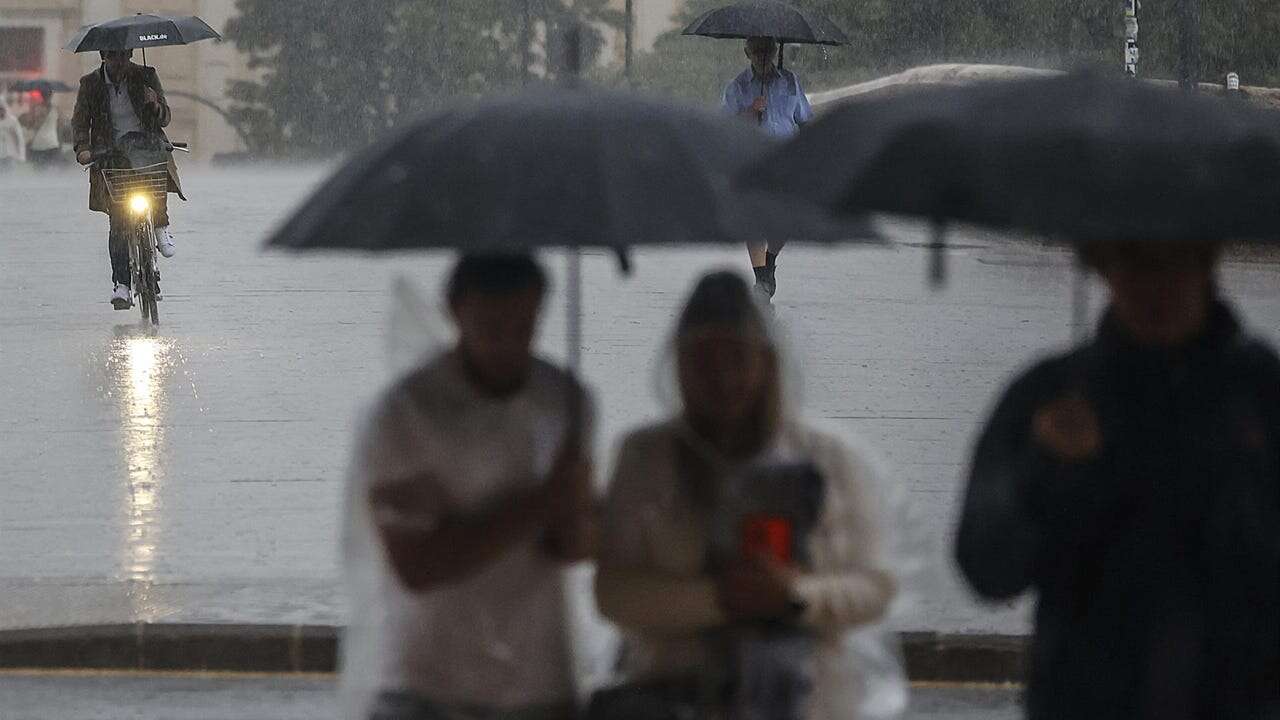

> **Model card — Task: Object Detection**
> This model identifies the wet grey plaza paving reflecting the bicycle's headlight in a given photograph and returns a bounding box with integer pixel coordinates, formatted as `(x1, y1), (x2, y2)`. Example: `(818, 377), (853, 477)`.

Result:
(0, 168), (1280, 633)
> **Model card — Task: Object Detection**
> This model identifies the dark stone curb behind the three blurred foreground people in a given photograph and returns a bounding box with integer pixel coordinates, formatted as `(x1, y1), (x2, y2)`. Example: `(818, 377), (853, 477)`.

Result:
(0, 623), (1028, 683)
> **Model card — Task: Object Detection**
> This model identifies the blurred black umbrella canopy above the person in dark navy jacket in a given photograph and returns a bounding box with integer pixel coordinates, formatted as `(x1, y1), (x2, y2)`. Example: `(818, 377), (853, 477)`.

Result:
(740, 73), (1280, 241)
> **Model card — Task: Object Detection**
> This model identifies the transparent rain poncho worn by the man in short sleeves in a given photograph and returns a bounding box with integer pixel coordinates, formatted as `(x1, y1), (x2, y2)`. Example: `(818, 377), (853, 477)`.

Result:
(339, 279), (617, 719)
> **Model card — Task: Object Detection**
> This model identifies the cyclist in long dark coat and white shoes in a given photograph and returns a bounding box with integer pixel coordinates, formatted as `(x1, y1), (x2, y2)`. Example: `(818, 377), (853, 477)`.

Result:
(72, 50), (187, 310)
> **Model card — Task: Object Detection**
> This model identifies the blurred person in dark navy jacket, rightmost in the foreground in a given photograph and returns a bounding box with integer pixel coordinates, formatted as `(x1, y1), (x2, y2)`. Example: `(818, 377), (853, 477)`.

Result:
(956, 243), (1280, 720)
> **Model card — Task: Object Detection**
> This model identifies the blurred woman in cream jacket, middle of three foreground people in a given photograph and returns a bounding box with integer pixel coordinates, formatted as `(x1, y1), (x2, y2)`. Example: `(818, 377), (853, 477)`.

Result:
(595, 273), (895, 719)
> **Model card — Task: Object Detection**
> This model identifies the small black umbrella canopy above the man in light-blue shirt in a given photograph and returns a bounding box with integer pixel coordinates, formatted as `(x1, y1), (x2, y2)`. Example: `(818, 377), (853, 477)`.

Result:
(684, 0), (849, 45)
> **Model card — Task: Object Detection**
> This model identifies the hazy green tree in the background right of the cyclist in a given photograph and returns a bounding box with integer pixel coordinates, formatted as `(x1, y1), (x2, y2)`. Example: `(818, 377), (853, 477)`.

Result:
(225, 0), (621, 156)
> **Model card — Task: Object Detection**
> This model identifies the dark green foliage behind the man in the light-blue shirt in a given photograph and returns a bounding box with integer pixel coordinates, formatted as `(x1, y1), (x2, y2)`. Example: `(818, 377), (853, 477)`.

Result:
(635, 0), (1280, 99)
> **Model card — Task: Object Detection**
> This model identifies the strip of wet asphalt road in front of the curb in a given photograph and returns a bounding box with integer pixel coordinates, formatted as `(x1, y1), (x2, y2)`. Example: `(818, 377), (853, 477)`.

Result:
(0, 674), (1019, 720)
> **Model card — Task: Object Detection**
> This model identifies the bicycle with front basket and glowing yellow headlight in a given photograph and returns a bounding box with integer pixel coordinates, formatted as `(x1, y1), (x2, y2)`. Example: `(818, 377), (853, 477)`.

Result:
(93, 134), (191, 325)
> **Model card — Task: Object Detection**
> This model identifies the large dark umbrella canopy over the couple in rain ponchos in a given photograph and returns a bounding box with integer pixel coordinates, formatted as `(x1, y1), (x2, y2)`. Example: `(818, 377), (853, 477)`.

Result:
(269, 88), (869, 251)
